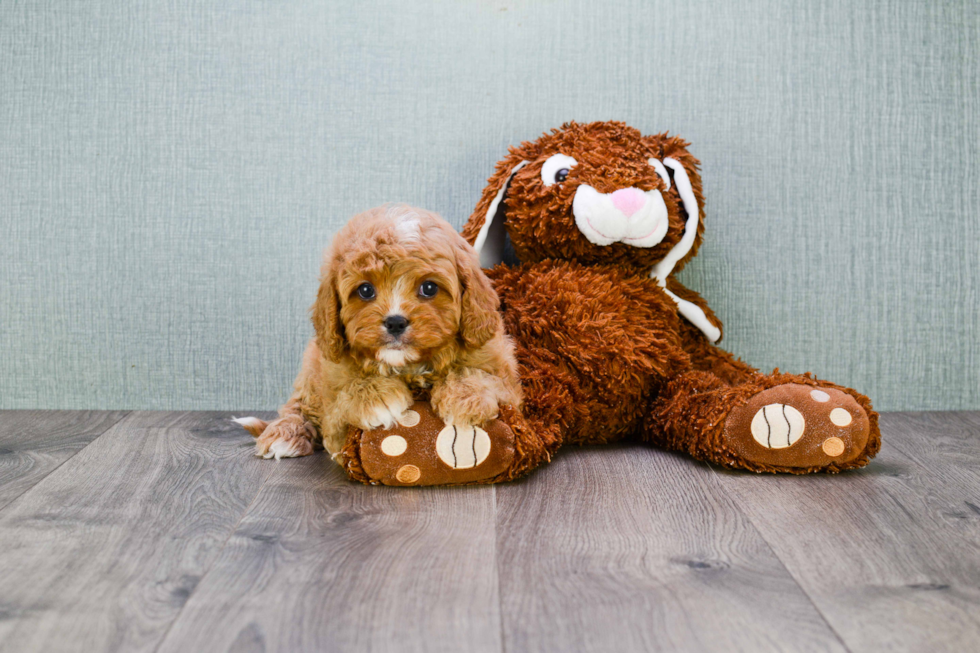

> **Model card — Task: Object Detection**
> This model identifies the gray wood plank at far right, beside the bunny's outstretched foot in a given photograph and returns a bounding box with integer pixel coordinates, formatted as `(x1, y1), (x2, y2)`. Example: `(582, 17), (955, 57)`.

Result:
(717, 414), (980, 651)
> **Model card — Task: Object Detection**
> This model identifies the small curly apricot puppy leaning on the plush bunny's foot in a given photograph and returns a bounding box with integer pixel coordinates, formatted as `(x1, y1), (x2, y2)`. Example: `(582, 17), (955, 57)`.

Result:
(235, 205), (521, 459)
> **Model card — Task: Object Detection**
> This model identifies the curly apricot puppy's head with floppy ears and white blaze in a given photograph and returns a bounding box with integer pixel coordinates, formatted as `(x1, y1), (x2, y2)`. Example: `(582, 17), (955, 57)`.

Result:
(313, 205), (503, 368)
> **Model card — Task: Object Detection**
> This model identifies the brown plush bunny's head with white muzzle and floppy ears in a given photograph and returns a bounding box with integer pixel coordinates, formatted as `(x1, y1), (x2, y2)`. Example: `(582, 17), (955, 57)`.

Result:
(463, 122), (704, 282)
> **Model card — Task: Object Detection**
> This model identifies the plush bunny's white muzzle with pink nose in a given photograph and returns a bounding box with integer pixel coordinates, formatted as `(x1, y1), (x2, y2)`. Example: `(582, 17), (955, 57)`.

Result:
(572, 184), (668, 248)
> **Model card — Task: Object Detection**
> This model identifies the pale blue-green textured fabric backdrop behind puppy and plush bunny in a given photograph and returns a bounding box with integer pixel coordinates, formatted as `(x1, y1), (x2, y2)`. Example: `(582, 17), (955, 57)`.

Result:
(0, 0), (980, 410)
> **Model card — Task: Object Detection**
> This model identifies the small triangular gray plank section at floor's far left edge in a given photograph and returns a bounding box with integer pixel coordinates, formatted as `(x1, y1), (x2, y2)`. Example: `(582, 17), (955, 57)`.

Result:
(0, 410), (127, 510)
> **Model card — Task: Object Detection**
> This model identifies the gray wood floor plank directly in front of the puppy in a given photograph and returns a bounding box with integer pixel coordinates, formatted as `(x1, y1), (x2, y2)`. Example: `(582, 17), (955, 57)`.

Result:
(160, 454), (501, 653)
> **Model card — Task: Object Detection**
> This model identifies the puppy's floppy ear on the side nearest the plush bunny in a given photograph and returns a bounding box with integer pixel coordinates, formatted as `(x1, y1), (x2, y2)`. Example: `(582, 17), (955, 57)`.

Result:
(456, 239), (504, 348)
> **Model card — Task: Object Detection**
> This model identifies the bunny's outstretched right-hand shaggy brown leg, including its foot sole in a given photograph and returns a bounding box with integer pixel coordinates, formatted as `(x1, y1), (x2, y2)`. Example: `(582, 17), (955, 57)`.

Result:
(641, 328), (881, 474)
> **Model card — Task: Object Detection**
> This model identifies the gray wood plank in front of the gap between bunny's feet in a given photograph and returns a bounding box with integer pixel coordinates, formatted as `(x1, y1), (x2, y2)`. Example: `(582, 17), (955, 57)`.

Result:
(497, 446), (844, 652)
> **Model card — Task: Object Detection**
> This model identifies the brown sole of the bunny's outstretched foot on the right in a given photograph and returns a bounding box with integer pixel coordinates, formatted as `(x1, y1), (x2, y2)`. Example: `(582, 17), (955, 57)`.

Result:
(724, 383), (870, 471)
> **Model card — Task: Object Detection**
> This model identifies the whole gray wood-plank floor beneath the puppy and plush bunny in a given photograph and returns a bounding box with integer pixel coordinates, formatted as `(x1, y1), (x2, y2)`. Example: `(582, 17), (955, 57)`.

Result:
(0, 411), (980, 653)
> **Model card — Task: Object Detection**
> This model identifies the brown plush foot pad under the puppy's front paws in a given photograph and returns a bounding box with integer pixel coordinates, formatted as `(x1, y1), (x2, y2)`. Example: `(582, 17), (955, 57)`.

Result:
(359, 401), (514, 486)
